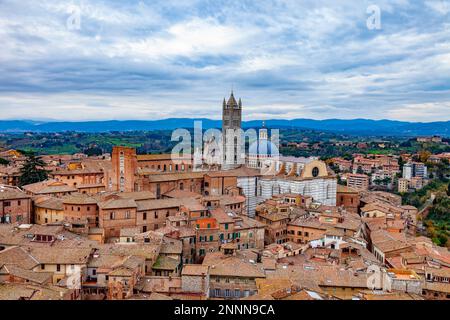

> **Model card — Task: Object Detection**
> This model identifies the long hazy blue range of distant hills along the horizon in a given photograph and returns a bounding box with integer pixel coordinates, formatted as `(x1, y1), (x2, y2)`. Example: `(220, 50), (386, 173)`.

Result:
(0, 118), (450, 137)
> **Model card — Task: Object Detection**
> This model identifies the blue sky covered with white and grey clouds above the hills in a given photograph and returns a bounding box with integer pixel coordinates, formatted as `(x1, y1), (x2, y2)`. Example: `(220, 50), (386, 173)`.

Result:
(0, 0), (450, 122)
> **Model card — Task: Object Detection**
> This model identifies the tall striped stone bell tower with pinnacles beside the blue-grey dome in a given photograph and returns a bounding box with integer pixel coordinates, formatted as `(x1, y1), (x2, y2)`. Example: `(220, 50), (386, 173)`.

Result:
(222, 91), (242, 170)
